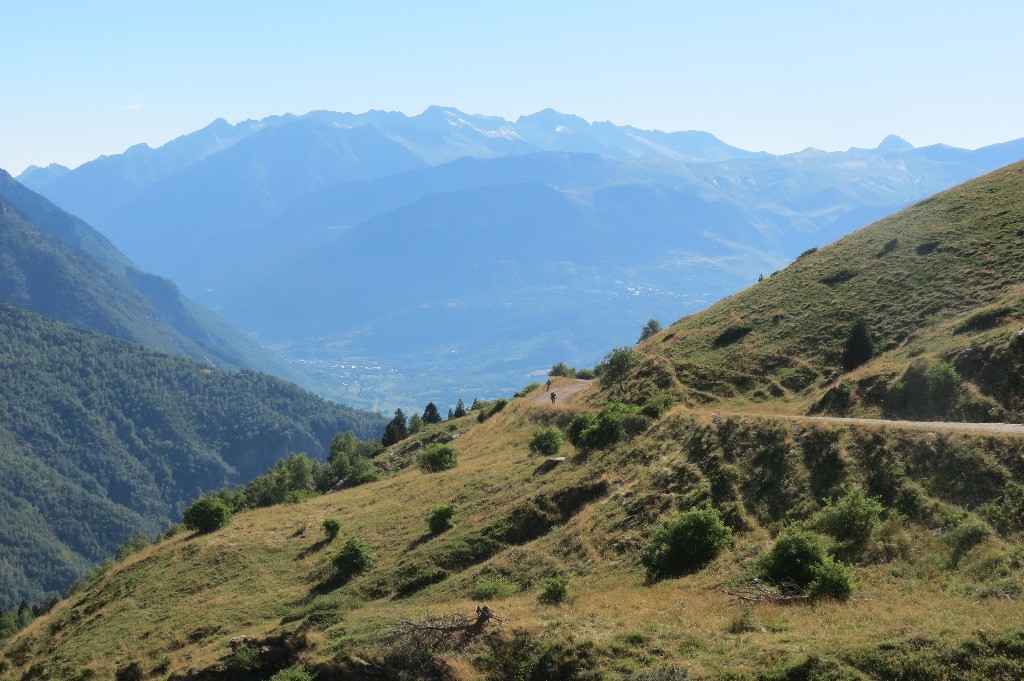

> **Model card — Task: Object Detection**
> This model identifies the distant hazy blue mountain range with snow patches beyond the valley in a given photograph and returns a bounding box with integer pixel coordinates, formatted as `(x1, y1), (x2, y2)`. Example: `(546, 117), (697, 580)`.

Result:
(20, 107), (1024, 409)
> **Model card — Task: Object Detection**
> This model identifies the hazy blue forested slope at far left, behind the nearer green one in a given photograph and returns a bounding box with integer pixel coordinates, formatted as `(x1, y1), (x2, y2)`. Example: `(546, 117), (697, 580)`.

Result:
(0, 170), (309, 383)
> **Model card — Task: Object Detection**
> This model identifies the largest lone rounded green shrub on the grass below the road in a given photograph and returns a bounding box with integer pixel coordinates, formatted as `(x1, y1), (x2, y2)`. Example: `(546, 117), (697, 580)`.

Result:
(641, 508), (732, 579)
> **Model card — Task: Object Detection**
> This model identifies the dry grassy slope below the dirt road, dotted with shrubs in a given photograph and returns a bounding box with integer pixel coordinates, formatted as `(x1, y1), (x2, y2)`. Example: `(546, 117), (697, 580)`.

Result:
(0, 381), (1024, 679)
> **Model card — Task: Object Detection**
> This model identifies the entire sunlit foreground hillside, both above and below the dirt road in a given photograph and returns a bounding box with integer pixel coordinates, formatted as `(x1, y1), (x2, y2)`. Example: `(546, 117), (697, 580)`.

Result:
(0, 164), (1024, 681)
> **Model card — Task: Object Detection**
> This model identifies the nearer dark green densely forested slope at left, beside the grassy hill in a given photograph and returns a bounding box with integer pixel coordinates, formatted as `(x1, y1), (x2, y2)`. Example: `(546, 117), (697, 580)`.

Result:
(0, 303), (383, 608)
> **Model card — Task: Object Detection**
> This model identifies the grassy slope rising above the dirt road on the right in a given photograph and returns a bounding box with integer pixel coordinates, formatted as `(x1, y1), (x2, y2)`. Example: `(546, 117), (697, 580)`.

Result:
(621, 164), (1024, 421)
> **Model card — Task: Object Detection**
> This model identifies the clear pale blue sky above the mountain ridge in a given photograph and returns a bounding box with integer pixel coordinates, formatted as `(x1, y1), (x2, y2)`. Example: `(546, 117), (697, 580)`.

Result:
(0, 0), (1024, 174)
